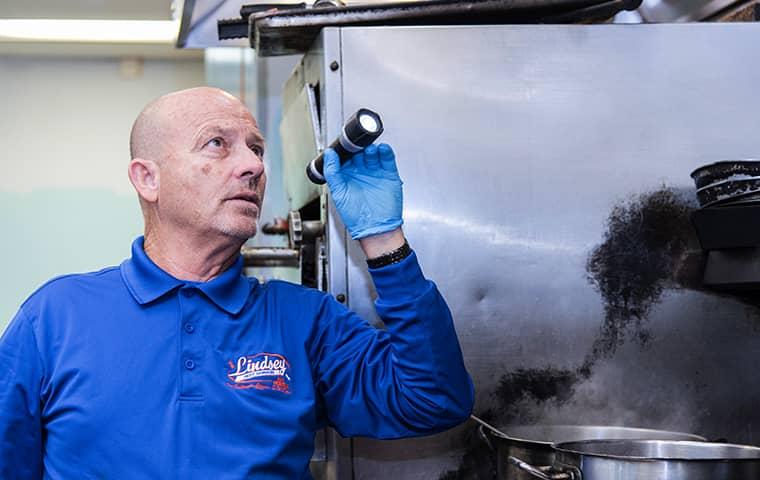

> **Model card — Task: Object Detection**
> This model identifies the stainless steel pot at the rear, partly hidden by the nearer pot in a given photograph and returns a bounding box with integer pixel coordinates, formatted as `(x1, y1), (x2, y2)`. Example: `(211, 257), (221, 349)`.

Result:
(482, 425), (705, 480)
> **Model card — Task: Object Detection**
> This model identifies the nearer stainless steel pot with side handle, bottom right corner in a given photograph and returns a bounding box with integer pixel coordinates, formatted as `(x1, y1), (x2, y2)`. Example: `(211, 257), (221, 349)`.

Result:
(510, 440), (760, 480)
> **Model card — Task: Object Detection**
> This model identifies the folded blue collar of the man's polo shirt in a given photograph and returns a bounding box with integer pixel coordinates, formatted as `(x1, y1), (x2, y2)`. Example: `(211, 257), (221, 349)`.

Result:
(121, 236), (253, 315)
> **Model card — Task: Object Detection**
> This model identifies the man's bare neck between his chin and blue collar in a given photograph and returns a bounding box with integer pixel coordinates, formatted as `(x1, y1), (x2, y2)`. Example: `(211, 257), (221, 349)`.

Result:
(144, 229), (244, 282)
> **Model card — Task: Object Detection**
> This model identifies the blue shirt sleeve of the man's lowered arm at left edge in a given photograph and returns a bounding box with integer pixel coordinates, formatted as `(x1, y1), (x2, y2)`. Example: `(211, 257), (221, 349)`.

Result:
(0, 310), (42, 480)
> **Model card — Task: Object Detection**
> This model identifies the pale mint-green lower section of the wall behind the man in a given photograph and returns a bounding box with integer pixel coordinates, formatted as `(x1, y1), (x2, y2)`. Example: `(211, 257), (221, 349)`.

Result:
(0, 188), (142, 322)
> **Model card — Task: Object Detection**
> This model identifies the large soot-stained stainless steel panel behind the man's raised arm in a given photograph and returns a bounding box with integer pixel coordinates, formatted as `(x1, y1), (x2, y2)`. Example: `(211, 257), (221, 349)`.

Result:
(316, 24), (760, 479)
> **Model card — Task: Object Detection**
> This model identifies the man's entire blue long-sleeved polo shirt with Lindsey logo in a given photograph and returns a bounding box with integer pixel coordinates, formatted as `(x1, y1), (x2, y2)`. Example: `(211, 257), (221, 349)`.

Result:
(0, 238), (473, 479)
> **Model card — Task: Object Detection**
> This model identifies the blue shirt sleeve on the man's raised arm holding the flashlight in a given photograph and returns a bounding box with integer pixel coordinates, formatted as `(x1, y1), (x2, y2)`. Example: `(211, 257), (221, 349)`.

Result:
(312, 253), (474, 439)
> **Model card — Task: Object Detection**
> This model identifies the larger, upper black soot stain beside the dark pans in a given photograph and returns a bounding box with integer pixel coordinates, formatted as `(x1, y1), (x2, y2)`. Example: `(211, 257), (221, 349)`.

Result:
(581, 187), (704, 368)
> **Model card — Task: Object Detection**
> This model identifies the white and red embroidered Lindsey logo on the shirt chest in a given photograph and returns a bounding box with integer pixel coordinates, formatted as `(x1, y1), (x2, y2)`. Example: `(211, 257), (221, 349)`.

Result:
(227, 353), (290, 395)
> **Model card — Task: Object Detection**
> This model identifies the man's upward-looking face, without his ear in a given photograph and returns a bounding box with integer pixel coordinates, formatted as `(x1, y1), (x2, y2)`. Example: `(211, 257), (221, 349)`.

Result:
(157, 93), (266, 241)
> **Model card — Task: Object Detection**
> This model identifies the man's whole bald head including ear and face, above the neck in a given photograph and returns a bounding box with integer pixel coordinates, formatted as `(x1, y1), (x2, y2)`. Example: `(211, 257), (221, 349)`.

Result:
(128, 87), (266, 246)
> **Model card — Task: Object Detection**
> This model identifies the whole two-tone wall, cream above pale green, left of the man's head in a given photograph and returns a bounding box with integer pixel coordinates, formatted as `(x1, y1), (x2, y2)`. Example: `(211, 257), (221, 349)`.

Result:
(0, 56), (205, 330)
